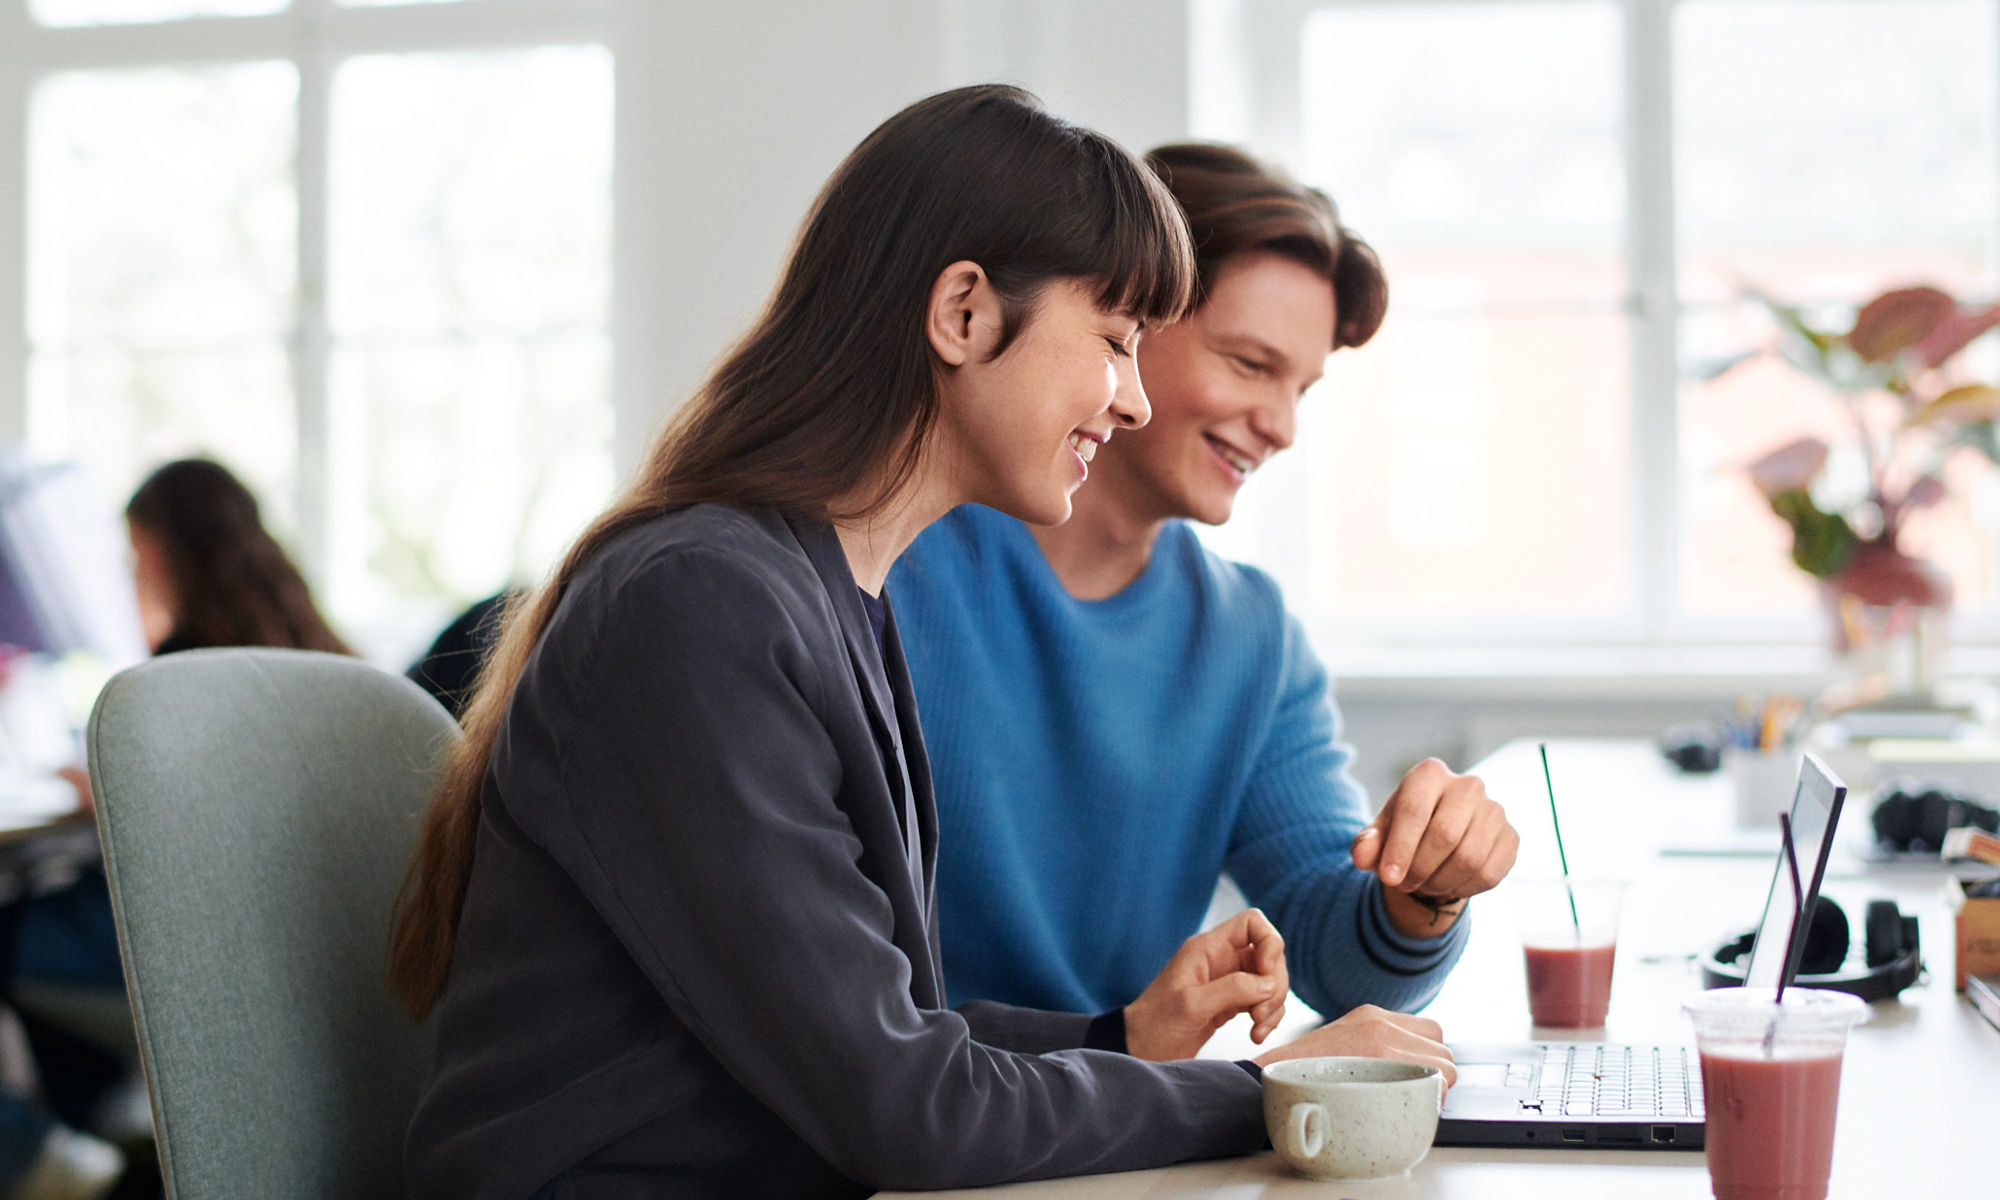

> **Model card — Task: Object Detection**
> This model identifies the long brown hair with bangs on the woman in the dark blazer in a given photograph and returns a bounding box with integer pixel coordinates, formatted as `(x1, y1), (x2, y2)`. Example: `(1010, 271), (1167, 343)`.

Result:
(390, 86), (1194, 1018)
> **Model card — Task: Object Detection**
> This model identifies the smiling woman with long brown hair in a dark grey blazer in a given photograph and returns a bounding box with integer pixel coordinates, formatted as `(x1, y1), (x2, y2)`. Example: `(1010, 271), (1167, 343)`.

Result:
(390, 86), (1442, 1200)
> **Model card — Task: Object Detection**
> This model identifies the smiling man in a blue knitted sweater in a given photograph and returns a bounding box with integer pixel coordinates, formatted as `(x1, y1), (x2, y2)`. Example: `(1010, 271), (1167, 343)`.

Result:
(888, 146), (1518, 1058)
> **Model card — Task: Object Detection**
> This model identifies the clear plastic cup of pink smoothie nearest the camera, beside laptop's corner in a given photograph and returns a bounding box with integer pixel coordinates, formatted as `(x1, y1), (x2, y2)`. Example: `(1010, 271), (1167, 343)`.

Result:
(1682, 988), (1868, 1200)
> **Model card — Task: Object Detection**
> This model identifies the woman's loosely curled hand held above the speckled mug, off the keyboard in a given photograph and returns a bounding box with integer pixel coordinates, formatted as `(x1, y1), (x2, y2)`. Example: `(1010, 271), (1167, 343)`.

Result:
(1126, 908), (1290, 1062)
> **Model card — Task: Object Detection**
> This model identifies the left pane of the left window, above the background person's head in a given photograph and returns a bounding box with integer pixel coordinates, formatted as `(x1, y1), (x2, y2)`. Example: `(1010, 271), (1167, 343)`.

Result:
(28, 62), (298, 530)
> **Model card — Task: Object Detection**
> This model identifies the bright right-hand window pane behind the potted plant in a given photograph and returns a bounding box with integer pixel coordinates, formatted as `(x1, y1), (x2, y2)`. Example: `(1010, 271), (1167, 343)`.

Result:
(1674, 0), (2000, 616)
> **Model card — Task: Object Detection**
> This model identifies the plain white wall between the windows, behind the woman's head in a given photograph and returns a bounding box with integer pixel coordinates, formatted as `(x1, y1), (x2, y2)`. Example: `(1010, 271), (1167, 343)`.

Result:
(614, 0), (1188, 474)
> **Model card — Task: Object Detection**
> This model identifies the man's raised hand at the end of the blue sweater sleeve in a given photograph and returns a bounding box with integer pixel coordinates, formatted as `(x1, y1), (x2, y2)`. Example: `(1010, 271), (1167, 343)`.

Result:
(1350, 758), (1520, 938)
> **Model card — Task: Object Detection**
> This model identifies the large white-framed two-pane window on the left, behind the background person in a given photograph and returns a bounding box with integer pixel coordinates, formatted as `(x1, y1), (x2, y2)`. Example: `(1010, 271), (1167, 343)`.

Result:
(0, 0), (614, 662)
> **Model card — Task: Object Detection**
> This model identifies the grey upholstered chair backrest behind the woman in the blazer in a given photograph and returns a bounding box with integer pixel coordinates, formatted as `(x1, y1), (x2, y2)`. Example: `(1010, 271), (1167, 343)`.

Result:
(90, 650), (458, 1200)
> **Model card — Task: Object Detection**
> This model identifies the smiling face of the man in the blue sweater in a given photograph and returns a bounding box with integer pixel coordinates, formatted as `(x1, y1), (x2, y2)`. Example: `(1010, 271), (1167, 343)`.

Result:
(1096, 252), (1334, 524)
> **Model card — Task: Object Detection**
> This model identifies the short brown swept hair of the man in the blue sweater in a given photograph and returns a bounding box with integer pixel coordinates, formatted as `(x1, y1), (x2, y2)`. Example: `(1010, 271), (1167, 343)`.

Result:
(1146, 142), (1388, 350)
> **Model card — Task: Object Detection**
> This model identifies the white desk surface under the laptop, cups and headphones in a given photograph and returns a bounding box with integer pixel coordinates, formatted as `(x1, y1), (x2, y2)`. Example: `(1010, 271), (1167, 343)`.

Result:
(882, 742), (2000, 1200)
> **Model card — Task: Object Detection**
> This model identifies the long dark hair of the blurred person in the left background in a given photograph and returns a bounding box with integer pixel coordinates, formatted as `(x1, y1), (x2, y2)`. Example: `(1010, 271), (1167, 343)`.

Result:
(126, 458), (352, 654)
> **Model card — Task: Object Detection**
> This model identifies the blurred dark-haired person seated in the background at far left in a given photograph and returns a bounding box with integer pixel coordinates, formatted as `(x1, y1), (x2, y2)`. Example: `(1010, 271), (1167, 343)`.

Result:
(14, 458), (352, 1200)
